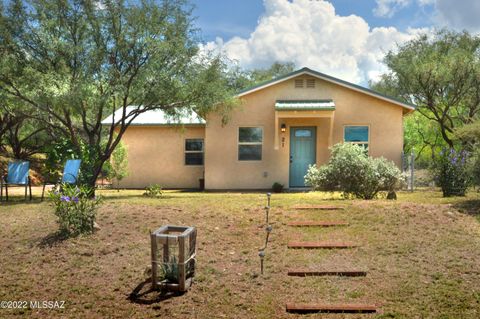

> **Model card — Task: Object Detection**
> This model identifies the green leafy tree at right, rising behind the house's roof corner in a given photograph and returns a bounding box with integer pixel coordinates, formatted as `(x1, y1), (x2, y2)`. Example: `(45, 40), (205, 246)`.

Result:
(372, 30), (480, 147)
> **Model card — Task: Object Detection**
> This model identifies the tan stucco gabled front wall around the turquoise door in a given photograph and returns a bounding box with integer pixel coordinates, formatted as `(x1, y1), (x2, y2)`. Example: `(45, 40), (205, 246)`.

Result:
(205, 76), (403, 189)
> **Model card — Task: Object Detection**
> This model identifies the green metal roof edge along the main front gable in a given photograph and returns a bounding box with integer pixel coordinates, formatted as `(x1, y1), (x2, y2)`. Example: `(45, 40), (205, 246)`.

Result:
(237, 67), (416, 110)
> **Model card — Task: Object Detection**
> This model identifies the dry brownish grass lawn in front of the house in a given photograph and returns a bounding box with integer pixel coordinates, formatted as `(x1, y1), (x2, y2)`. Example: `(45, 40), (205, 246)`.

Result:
(0, 190), (480, 318)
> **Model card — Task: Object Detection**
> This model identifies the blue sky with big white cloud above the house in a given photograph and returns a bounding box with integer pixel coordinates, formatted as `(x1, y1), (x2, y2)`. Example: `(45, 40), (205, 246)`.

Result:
(192, 0), (480, 85)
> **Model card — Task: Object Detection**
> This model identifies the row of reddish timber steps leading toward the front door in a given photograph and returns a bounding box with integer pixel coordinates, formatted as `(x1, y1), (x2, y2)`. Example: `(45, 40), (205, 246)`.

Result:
(286, 205), (377, 313)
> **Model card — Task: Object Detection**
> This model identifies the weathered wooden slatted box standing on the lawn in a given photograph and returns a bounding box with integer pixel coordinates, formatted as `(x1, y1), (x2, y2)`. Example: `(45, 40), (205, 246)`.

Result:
(150, 225), (197, 292)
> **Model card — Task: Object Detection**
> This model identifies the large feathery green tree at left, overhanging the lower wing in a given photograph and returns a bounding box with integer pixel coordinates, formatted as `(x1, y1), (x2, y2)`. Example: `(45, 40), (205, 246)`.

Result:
(0, 0), (235, 186)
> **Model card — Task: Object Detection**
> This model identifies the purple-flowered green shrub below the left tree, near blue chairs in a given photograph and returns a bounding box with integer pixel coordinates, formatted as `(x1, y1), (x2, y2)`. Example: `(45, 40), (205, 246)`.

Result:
(50, 184), (101, 236)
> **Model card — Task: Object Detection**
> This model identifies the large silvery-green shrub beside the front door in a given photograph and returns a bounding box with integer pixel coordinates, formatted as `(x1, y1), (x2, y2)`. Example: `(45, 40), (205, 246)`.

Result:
(305, 143), (402, 199)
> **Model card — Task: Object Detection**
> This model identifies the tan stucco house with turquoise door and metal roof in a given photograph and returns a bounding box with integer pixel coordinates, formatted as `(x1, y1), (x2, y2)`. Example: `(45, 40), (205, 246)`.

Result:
(103, 68), (415, 190)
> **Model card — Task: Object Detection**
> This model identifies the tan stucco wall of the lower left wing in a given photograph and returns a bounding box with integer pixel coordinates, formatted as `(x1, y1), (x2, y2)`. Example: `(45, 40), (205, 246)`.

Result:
(120, 126), (205, 188)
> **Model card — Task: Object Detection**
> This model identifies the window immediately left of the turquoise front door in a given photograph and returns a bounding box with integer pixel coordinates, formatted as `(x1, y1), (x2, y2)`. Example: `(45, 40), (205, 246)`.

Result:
(238, 127), (263, 161)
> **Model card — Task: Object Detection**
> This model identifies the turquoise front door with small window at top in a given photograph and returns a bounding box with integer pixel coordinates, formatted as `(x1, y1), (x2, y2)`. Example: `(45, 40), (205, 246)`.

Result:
(290, 127), (316, 187)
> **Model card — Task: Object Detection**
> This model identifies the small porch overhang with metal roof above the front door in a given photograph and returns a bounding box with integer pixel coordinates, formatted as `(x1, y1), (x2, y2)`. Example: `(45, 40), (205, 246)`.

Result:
(274, 100), (335, 150)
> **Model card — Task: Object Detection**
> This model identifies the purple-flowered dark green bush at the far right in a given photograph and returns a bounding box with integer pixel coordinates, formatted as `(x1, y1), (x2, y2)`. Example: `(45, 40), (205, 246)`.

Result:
(432, 148), (472, 197)
